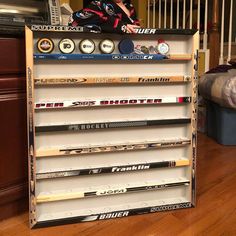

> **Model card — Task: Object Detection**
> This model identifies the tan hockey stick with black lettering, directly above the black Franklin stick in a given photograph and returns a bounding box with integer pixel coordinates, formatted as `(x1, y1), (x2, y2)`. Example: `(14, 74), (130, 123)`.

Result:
(36, 139), (191, 157)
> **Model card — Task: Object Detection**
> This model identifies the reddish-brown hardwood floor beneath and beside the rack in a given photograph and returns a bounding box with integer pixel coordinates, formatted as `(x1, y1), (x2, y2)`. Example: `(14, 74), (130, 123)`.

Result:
(0, 134), (236, 236)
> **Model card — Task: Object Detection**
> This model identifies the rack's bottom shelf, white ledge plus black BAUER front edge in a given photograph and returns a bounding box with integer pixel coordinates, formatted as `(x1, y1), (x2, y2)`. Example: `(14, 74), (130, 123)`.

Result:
(34, 197), (193, 228)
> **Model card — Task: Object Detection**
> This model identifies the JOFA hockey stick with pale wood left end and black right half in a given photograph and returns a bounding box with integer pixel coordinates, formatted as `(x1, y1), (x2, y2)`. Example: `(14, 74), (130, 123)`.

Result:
(36, 181), (190, 203)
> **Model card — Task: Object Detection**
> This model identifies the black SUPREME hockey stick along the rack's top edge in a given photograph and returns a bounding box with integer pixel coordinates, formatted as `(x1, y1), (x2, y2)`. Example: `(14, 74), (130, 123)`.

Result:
(29, 25), (197, 35)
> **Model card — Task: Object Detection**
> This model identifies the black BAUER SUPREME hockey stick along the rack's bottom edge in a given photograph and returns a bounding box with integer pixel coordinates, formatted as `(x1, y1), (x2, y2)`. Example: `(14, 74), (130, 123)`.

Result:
(34, 201), (192, 228)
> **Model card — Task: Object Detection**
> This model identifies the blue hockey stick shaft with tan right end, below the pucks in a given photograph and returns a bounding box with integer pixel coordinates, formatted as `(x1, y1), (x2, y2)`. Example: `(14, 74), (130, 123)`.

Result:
(34, 53), (192, 61)
